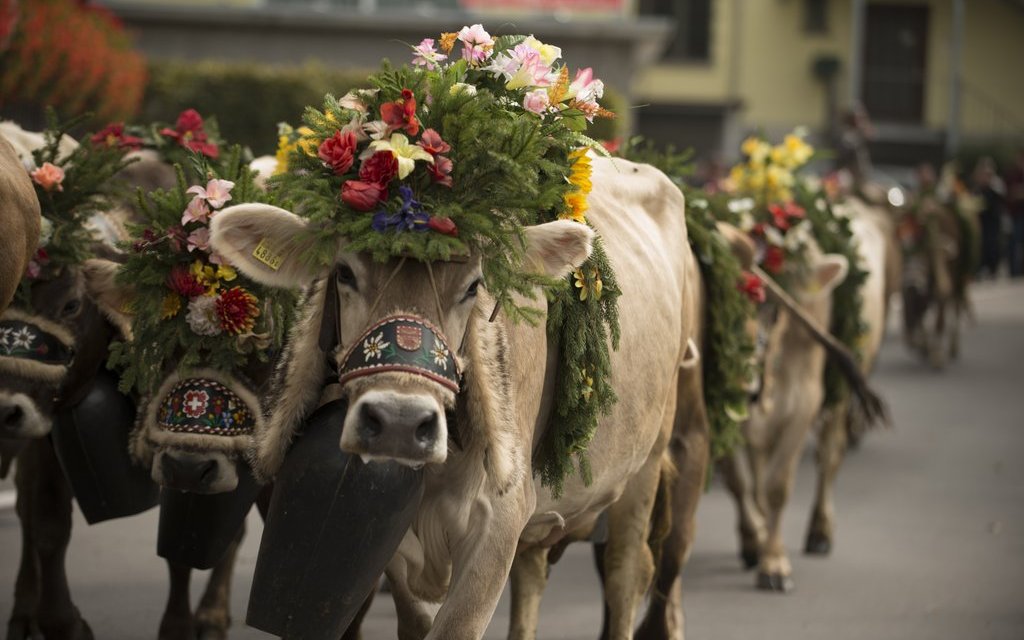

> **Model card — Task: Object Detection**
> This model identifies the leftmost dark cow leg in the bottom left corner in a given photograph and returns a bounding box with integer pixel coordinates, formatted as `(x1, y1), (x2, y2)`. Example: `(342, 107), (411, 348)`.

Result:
(7, 444), (43, 640)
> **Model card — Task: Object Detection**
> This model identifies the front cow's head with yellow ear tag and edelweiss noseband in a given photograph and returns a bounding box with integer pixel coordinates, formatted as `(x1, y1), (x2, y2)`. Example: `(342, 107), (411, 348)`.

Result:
(211, 204), (593, 467)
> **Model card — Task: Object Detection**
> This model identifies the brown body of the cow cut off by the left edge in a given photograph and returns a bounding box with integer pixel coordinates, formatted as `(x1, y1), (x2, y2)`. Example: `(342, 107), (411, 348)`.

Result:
(0, 135), (39, 313)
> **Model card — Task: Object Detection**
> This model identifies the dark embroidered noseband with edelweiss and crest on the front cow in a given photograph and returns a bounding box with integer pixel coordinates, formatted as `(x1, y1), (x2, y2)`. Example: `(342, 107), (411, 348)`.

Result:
(338, 315), (462, 393)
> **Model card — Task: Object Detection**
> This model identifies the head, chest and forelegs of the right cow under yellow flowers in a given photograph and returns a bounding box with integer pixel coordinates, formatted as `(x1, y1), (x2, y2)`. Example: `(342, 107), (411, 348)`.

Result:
(720, 240), (849, 591)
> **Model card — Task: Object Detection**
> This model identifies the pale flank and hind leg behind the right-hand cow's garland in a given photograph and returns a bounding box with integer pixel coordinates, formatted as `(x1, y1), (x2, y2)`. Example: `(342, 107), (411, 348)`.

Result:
(804, 198), (893, 555)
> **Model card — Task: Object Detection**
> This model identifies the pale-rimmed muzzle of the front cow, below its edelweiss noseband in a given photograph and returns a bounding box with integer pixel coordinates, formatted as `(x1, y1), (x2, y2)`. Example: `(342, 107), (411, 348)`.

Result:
(341, 374), (447, 469)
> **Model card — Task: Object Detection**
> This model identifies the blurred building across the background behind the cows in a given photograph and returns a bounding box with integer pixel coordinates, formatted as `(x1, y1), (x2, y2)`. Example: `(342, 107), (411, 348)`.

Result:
(111, 0), (1024, 163)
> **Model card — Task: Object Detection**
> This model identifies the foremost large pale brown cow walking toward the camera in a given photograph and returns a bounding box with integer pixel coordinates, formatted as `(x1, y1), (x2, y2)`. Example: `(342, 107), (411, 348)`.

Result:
(211, 159), (699, 638)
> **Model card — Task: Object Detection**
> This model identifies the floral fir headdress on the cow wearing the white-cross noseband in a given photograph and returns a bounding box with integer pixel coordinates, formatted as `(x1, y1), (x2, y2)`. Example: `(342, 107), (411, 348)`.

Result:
(111, 146), (292, 393)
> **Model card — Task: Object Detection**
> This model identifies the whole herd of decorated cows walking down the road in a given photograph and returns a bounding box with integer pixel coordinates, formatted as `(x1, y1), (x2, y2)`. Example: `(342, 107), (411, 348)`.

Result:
(0, 114), (967, 640)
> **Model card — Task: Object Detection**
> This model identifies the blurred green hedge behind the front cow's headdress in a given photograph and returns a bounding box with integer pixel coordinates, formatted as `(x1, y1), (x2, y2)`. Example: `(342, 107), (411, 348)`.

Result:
(138, 61), (626, 156)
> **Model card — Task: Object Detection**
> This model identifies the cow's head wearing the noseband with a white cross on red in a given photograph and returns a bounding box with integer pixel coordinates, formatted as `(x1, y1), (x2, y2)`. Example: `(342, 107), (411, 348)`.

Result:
(85, 260), (271, 494)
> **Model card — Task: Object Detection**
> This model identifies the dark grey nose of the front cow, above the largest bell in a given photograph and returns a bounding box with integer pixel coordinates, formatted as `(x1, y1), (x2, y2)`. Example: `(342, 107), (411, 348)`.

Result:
(358, 402), (439, 451)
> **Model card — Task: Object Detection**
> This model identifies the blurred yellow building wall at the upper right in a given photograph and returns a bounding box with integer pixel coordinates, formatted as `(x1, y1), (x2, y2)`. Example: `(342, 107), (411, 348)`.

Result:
(634, 0), (1024, 136)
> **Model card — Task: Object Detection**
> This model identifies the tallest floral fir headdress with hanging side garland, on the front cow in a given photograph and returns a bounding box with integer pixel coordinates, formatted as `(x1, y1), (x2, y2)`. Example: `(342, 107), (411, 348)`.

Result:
(271, 25), (618, 488)
